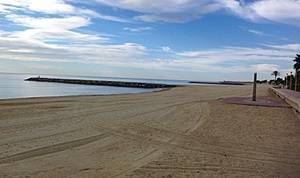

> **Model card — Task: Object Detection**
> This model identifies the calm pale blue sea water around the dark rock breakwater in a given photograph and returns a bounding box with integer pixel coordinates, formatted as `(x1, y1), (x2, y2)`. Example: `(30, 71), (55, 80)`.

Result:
(0, 73), (187, 99)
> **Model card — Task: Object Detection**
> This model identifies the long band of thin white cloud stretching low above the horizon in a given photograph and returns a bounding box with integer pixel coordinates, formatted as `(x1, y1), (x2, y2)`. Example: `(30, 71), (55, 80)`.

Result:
(0, 26), (300, 73)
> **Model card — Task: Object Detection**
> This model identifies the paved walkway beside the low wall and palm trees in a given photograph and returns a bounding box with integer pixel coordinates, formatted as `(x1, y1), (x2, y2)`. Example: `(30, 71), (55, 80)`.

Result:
(272, 88), (300, 112)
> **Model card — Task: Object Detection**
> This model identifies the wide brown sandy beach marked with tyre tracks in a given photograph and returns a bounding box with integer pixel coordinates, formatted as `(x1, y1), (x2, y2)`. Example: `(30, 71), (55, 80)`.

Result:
(0, 85), (300, 177)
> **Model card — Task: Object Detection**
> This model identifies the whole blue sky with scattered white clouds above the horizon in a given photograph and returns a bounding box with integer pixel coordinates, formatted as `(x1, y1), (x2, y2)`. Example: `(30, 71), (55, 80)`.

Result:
(0, 0), (300, 81)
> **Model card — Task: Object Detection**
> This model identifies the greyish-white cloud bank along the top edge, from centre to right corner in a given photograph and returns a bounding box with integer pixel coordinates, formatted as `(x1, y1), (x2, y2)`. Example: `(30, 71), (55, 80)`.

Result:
(91, 0), (300, 26)
